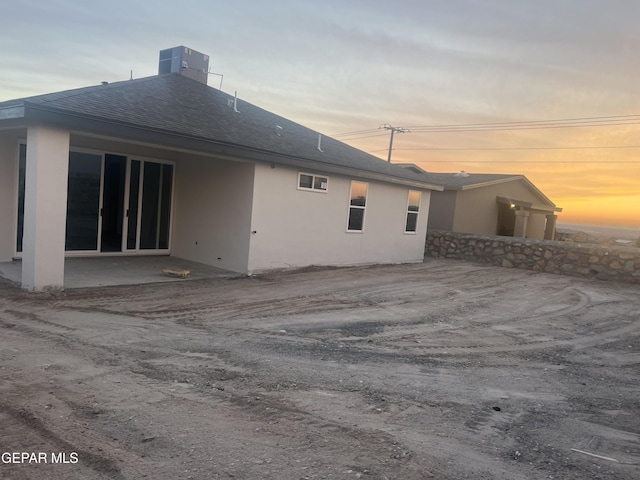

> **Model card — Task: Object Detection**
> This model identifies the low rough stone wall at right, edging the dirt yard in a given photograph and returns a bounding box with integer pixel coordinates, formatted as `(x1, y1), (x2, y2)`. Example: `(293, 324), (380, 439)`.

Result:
(425, 231), (640, 284)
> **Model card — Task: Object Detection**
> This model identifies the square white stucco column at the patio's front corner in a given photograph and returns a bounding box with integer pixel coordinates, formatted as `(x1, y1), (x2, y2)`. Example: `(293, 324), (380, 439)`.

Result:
(22, 127), (69, 291)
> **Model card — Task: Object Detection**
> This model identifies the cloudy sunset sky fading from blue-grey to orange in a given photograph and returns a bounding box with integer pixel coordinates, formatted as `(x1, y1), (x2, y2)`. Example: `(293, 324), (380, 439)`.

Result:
(0, 0), (640, 228)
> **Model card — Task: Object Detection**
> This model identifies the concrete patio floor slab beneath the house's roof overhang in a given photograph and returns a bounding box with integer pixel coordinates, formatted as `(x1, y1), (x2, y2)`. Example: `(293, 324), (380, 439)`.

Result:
(0, 255), (243, 289)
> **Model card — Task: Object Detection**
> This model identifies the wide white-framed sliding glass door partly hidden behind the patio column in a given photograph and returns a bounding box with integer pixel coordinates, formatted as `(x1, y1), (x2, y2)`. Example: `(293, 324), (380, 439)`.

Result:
(16, 145), (173, 253)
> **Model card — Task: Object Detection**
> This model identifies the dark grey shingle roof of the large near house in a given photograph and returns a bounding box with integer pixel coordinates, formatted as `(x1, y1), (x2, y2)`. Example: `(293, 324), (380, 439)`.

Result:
(0, 74), (440, 188)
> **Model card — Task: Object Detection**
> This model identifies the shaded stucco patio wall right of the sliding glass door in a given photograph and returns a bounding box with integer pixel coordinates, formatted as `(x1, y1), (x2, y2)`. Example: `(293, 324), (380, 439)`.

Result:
(171, 155), (254, 273)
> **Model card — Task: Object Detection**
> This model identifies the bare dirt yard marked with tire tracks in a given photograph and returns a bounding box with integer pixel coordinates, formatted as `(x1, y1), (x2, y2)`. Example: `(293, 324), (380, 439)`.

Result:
(0, 260), (640, 480)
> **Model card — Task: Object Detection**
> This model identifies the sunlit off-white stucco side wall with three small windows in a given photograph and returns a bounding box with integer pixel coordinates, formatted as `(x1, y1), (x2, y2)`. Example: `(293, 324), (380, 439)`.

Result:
(249, 164), (430, 272)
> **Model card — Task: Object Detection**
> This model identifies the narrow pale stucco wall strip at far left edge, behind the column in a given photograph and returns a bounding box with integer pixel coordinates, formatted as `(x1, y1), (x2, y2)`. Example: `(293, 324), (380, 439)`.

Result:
(0, 135), (18, 262)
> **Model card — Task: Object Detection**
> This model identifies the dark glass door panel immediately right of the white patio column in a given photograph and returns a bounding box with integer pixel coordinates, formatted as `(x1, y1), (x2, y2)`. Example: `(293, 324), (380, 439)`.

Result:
(65, 152), (102, 251)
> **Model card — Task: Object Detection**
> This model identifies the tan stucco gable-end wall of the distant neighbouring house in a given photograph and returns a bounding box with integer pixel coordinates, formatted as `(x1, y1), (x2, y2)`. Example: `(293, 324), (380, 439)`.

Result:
(450, 180), (546, 238)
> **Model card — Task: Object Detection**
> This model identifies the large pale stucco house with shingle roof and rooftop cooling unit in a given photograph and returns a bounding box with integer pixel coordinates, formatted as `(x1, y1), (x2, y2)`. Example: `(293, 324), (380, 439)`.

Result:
(0, 47), (442, 291)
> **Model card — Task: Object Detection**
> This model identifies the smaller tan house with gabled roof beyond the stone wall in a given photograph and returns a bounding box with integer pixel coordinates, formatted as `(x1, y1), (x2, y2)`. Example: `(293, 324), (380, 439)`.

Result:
(402, 164), (562, 240)
